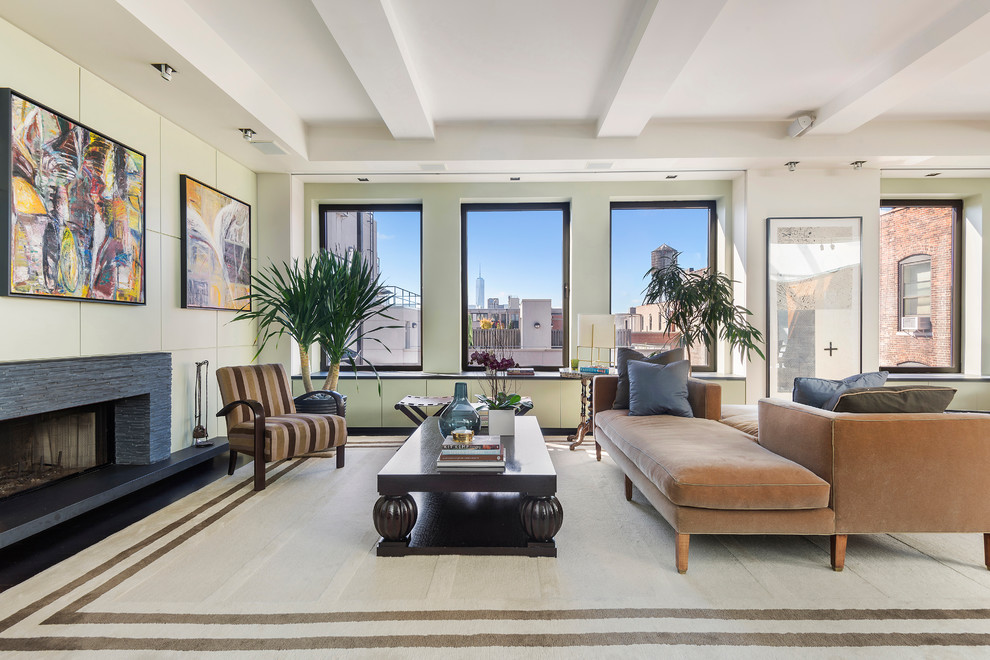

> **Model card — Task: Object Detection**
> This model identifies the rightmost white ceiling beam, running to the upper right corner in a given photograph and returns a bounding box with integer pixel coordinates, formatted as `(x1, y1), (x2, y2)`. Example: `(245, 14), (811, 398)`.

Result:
(806, 0), (990, 135)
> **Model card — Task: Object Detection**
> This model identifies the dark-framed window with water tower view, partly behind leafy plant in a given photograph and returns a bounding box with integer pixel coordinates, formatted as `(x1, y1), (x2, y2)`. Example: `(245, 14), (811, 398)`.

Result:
(611, 201), (715, 371)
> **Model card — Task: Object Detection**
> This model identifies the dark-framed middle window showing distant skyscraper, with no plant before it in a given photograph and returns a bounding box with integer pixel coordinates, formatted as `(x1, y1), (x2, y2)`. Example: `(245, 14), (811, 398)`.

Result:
(461, 204), (570, 370)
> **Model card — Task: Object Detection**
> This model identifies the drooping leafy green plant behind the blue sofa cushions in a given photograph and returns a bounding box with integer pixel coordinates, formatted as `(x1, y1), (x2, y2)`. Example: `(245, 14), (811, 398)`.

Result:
(643, 252), (765, 362)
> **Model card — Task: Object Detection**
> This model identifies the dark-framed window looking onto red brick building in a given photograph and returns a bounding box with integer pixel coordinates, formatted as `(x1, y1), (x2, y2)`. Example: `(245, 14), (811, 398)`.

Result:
(880, 200), (962, 372)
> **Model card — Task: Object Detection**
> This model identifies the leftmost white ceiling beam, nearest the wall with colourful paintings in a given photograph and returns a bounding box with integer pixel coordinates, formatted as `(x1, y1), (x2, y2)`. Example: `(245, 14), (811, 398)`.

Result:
(116, 0), (308, 158)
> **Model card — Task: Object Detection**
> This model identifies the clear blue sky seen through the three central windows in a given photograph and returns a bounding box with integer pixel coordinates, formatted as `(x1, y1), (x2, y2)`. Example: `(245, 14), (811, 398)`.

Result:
(375, 208), (708, 314)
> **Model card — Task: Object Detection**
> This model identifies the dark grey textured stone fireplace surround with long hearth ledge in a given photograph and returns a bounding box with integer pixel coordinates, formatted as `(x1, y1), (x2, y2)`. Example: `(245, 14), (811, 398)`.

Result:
(0, 353), (228, 548)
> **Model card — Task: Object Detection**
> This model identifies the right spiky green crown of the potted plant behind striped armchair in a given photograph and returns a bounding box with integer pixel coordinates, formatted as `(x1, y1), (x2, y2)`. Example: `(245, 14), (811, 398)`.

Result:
(314, 252), (399, 391)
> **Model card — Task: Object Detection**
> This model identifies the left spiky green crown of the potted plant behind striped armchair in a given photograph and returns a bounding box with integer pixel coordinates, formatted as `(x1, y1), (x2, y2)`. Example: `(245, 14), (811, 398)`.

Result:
(234, 257), (324, 392)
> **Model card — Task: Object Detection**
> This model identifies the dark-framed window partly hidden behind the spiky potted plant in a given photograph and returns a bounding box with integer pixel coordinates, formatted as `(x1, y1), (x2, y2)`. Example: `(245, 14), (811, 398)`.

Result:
(320, 204), (423, 370)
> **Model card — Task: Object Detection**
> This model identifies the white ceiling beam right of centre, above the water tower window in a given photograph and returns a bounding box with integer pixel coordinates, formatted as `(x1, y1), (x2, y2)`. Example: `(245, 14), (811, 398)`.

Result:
(598, 0), (727, 137)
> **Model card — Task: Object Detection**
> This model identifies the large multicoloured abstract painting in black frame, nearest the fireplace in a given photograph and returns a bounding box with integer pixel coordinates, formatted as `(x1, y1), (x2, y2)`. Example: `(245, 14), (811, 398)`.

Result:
(0, 89), (145, 305)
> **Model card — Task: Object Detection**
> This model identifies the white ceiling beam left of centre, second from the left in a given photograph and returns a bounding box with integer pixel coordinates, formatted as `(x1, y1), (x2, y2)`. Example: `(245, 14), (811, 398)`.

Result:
(313, 0), (434, 140)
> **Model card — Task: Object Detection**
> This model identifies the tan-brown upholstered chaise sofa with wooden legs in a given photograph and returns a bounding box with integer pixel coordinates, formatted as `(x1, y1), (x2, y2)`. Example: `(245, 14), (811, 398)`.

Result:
(594, 376), (990, 573)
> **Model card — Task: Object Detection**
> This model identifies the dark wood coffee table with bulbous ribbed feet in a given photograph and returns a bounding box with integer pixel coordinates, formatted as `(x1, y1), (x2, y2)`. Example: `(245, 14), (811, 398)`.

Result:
(374, 417), (564, 557)
